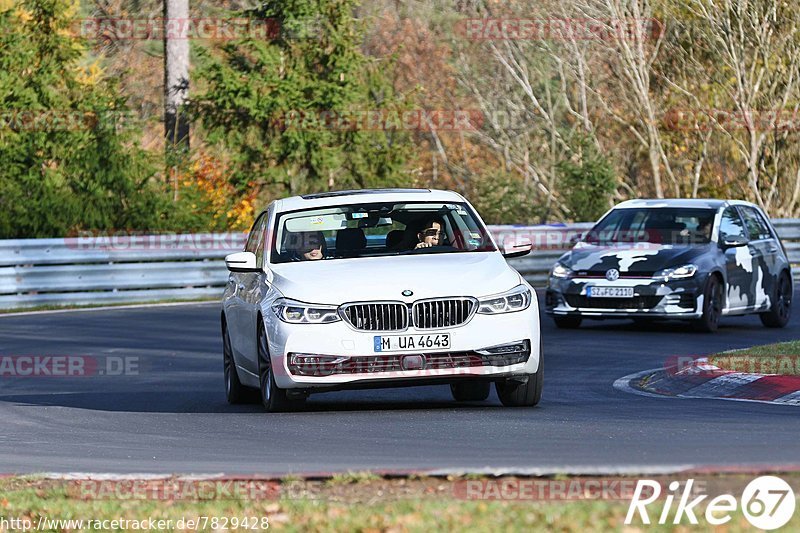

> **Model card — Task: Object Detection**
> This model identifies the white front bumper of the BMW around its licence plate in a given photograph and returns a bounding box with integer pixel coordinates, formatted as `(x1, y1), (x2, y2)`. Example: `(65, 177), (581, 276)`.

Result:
(268, 303), (540, 389)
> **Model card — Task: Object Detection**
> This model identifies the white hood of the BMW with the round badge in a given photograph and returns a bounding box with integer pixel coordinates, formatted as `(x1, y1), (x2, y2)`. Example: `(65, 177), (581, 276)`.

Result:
(270, 252), (522, 305)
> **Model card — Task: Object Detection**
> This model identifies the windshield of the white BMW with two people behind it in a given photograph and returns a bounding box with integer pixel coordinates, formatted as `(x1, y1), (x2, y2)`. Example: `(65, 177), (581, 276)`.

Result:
(271, 202), (497, 263)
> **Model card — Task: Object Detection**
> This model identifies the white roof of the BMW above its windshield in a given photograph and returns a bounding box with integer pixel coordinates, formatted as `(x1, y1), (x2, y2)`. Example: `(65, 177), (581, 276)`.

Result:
(275, 189), (465, 212)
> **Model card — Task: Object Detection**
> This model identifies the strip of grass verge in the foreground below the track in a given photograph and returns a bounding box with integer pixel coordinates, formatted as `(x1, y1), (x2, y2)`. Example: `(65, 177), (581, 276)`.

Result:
(0, 474), (800, 532)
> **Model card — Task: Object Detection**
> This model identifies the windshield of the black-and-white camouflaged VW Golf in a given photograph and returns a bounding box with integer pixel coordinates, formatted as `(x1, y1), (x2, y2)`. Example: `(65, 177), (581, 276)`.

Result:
(584, 207), (716, 244)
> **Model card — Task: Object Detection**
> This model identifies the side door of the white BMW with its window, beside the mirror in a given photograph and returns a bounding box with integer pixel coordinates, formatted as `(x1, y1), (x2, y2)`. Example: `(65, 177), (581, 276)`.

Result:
(226, 214), (266, 366)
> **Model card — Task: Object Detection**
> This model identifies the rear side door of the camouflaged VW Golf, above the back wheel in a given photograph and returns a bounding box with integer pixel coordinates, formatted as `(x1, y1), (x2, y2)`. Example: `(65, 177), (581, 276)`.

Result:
(739, 205), (782, 308)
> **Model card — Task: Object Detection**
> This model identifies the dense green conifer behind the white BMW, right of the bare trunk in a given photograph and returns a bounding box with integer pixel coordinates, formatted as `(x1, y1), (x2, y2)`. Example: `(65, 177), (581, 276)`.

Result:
(191, 0), (410, 198)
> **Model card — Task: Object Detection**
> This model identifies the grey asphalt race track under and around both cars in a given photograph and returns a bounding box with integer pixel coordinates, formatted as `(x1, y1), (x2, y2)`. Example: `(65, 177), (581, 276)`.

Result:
(0, 294), (800, 474)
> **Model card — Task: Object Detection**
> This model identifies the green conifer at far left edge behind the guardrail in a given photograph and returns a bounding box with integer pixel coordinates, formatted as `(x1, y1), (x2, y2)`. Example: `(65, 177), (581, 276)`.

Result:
(0, 0), (165, 238)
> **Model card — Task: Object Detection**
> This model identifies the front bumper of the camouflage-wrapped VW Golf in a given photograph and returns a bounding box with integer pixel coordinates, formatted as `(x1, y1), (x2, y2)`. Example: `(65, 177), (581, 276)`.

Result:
(545, 275), (705, 319)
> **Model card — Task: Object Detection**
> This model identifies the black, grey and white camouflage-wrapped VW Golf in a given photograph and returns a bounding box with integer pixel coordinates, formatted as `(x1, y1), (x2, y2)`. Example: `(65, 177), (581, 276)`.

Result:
(545, 200), (793, 331)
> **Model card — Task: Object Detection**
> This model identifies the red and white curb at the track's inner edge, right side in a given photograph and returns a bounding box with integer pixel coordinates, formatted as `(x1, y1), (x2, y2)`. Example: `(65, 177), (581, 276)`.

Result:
(614, 359), (800, 406)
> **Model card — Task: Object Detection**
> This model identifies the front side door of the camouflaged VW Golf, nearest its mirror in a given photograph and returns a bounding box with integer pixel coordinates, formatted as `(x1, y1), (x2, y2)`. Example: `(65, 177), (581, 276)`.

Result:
(718, 206), (753, 310)
